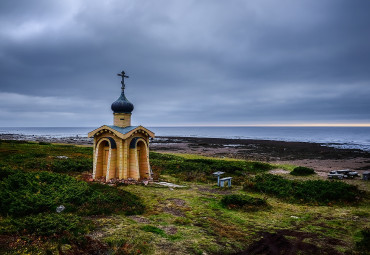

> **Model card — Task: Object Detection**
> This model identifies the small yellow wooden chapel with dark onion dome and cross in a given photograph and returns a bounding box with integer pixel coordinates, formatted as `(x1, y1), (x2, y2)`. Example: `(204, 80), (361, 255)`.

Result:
(88, 71), (154, 181)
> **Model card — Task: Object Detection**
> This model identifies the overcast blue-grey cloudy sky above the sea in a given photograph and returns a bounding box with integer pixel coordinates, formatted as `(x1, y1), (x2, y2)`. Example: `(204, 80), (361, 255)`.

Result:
(0, 0), (370, 127)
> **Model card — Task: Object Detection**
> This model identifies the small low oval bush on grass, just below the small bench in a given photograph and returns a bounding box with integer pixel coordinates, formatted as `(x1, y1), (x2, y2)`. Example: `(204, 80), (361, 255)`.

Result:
(221, 195), (267, 210)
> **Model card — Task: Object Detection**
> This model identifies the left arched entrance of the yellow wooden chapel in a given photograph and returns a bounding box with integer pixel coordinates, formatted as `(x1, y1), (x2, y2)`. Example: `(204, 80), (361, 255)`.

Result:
(93, 137), (117, 180)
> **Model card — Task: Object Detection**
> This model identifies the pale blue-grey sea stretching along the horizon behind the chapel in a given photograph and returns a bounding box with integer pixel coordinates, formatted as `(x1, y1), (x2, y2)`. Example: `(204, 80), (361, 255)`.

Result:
(0, 127), (370, 151)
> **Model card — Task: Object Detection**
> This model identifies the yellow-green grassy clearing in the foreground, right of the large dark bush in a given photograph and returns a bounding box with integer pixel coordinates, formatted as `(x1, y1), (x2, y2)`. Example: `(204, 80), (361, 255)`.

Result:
(90, 179), (369, 254)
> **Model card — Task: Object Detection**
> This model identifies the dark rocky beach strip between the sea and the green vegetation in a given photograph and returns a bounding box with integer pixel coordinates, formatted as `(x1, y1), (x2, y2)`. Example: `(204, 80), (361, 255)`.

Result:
(0, 134), (370, 176)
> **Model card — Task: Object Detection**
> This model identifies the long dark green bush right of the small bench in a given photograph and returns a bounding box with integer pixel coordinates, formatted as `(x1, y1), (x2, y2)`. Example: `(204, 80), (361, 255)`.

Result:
(244, 174), (362, 204)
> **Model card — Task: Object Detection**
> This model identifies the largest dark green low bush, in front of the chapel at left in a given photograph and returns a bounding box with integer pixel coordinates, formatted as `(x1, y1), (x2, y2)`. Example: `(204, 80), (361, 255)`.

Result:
(0, 171), (144, 217)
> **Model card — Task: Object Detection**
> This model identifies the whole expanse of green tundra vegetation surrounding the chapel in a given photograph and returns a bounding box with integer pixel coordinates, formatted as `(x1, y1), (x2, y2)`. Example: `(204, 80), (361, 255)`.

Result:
(0, 141), (370, 254)
